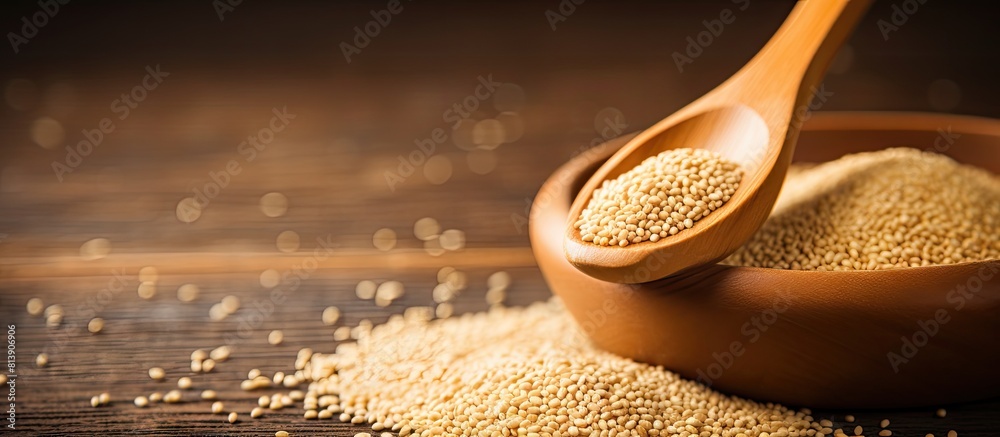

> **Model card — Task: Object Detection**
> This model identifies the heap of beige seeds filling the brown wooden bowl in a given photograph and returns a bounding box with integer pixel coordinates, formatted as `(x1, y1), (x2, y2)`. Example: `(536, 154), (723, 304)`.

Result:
(725, 152), (1000, 271)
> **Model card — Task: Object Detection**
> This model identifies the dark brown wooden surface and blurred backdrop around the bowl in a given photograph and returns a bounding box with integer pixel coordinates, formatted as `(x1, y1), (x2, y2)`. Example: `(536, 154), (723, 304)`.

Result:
(0, 0), (1000, 436)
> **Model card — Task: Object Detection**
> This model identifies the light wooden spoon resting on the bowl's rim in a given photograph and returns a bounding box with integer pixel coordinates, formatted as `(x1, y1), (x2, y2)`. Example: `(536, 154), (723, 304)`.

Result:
(564, 0), (870, 283)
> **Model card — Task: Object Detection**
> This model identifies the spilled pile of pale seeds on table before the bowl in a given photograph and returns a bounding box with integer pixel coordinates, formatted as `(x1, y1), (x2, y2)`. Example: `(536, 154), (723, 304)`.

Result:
(303, 301), (833, 436)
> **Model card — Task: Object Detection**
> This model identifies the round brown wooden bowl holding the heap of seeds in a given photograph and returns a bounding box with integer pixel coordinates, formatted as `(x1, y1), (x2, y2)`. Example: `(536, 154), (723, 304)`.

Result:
(529, 113), (1000, 408)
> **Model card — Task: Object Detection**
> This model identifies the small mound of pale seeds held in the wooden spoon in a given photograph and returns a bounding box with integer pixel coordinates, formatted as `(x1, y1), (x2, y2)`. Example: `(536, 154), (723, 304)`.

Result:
(574, 148), (743, 247)
